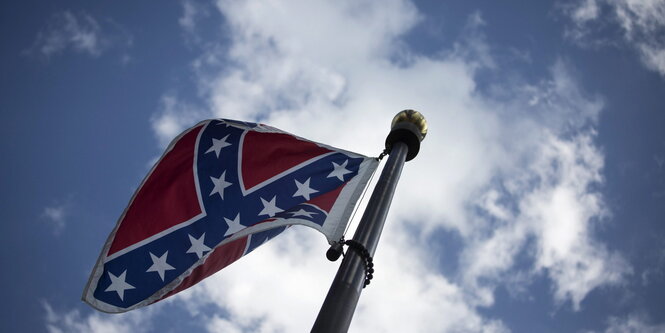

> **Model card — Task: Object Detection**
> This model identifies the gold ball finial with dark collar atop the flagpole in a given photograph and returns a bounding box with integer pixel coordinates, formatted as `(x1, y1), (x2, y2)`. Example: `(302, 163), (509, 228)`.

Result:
(386, 110), (427, 161)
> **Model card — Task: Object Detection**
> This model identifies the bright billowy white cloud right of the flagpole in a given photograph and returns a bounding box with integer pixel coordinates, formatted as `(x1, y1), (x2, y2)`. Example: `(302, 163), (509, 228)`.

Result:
(462, 62), (632, 309)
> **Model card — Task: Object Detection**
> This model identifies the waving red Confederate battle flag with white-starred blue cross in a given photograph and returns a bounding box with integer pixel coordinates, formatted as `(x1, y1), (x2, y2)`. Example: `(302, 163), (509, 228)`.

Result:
(83, 119), (377, 312)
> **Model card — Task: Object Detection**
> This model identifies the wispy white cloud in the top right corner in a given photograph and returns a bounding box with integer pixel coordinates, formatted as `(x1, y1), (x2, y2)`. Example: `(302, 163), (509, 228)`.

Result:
(563, 0), (665, 76)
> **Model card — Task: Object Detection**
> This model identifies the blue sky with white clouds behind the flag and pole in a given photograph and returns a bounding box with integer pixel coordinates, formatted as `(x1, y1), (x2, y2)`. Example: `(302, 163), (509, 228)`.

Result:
(0, 0), (665, 332)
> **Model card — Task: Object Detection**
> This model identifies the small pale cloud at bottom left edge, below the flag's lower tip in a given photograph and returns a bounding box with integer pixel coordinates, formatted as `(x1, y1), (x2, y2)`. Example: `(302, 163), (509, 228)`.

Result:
(42, 300), (154, 333)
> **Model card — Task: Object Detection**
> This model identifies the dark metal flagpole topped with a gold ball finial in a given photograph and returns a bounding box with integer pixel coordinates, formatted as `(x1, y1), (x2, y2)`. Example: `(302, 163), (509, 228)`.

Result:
(312, 110), (427, 333)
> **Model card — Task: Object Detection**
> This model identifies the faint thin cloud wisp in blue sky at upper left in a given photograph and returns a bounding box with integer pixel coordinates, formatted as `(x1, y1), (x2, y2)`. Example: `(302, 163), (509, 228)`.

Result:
(26, 11), (132, 58)
